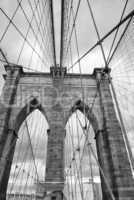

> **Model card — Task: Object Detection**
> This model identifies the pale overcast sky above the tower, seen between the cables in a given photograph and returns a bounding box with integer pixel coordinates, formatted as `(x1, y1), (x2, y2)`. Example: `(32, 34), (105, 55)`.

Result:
(0, 0), (134, 73)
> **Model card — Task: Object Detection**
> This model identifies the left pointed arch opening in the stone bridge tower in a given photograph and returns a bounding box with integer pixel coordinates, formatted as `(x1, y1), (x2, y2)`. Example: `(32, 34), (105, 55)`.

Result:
(7, 109), (49, 199)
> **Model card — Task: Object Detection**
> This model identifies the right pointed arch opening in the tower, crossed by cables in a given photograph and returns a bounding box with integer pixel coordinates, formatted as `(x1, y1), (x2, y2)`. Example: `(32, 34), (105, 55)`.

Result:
(64, 109), (102, 200)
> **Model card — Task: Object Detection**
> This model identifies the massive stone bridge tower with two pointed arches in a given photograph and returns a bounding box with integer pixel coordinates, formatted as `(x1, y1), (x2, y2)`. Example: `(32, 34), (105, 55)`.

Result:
(0, 66), (134, 200)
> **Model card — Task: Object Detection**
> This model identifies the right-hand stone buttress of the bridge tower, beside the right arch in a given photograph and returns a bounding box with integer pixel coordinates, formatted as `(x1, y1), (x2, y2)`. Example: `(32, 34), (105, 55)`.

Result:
(96, 70), (134, 200)
